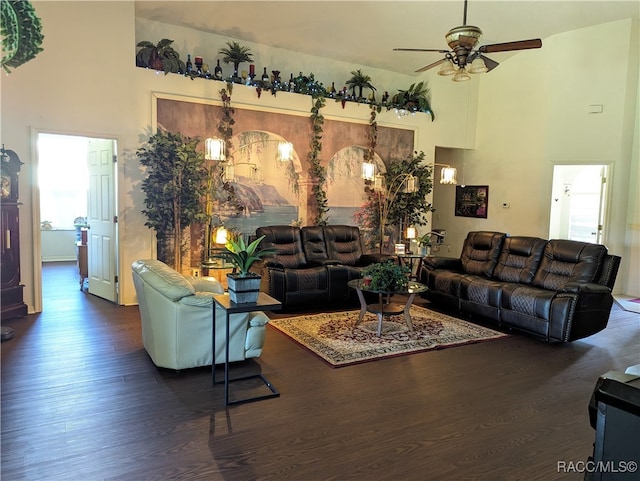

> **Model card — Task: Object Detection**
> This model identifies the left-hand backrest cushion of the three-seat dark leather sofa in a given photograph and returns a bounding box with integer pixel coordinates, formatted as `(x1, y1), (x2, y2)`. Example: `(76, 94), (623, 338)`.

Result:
(460, 231), (507, 277)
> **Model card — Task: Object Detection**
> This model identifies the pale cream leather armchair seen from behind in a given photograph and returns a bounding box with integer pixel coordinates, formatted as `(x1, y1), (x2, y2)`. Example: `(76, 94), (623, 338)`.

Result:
(131, 259), (269, 370)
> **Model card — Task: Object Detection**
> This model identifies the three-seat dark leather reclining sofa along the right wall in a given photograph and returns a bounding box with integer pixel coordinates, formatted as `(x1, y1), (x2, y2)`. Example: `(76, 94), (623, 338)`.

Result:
(419, 232), (620, 342)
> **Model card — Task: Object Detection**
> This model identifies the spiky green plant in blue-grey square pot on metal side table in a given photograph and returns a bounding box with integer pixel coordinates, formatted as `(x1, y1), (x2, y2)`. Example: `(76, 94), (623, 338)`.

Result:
(225, 235), (274, 304)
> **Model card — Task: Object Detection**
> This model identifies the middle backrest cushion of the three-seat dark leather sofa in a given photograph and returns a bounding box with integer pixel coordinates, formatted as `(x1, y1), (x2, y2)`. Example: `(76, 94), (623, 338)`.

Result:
(493, 236), (547, 284)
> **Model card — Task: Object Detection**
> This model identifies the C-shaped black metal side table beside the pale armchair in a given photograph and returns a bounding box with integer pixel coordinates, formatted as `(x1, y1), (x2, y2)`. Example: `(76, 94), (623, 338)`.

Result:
(211, 292), (282, 406)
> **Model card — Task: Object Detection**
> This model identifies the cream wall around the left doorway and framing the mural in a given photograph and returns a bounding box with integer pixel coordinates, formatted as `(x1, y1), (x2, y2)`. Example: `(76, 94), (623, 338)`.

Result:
(0, 1), (455, 312)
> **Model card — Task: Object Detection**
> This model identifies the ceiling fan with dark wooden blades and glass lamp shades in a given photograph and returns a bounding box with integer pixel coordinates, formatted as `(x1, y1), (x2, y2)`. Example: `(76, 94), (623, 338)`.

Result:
(394, 0), (542, 82)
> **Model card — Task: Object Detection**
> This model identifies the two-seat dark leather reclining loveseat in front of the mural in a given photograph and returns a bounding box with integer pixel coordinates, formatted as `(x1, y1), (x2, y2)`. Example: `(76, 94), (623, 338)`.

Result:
(253, 225), (390, 309)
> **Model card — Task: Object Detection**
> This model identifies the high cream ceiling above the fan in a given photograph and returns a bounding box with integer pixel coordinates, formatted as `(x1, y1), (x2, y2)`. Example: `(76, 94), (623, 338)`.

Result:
(136, 0), (640, 74)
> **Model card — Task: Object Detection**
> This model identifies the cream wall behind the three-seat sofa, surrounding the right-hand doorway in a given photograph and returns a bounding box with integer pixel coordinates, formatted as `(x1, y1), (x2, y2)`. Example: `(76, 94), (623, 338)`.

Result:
(434, 20), (640, 295)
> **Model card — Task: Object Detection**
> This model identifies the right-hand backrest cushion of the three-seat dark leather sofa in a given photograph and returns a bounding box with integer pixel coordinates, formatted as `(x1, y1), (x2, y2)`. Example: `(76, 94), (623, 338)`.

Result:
(533, 239), (607, 291)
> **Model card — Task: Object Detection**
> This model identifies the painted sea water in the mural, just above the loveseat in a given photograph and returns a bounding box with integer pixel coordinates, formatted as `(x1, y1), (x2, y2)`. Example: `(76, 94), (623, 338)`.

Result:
(225, 205), (357, 235)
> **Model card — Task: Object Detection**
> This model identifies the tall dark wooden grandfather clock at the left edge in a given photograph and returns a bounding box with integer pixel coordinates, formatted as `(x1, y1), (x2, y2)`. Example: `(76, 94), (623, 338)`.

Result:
(0, 145), (27, 319)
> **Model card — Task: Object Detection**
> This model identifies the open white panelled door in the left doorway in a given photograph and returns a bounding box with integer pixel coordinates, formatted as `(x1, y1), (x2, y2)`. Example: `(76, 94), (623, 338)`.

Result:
(87, 139), (118, 302)
